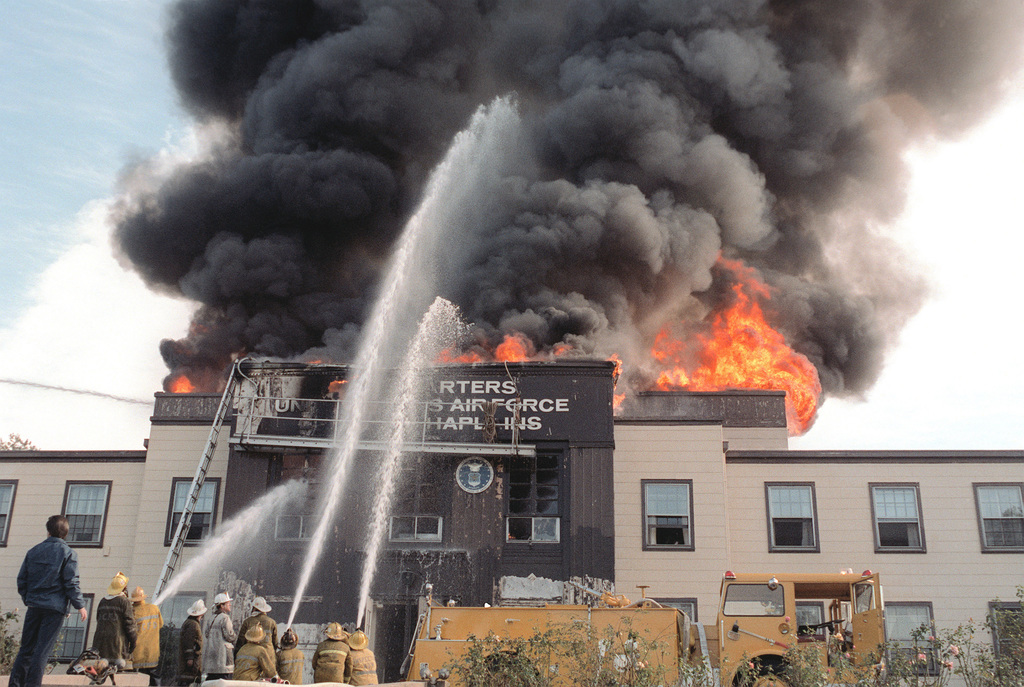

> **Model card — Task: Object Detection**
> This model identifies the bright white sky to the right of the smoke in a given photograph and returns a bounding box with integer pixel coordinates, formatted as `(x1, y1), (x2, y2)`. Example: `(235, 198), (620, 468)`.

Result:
(791, 90), (1024, 449)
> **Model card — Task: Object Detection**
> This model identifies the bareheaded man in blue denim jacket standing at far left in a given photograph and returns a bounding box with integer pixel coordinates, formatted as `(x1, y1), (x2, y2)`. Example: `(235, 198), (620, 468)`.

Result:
(7, 515), (88, 687)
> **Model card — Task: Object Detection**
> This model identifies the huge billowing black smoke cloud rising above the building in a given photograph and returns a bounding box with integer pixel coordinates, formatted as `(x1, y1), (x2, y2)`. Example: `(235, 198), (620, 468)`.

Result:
(115, 0), (1024, 413)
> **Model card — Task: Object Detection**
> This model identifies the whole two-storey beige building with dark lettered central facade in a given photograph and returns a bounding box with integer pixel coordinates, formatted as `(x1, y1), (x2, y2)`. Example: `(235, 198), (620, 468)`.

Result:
(0, 360), (1024, 679)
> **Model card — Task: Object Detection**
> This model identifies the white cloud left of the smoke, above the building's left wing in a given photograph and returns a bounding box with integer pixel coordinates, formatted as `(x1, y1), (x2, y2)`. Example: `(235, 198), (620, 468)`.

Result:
(0, 201), (194, 449)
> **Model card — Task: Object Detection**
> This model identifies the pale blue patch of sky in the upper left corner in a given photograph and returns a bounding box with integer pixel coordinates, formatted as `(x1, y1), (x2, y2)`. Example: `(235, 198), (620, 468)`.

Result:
(0, 0), (185, 321)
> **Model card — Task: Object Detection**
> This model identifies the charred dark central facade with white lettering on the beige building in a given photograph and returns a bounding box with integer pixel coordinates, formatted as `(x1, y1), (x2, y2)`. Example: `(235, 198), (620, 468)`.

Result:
(224, 361), (614, 679)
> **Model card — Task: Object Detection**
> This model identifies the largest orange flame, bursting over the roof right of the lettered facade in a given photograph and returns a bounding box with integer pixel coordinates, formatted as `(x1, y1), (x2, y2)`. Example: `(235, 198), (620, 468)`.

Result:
(651, 258), (821, 434)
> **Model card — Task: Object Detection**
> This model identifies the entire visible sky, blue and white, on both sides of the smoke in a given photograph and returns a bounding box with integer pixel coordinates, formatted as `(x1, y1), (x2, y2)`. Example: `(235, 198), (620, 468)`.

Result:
(0, 0), (1024, 449)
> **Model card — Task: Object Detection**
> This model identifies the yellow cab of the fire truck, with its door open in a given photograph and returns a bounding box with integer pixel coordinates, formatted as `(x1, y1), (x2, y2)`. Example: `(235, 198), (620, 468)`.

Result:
(717, 570), (885, 687)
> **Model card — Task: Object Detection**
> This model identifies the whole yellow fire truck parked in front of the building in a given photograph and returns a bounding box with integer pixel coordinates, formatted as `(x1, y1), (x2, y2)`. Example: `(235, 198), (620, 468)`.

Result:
(407, 570), (885, 687)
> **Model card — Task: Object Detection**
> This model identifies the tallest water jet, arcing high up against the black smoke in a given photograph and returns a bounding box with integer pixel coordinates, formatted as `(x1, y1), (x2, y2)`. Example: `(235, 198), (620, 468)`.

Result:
(287, 97), (519, 626)
